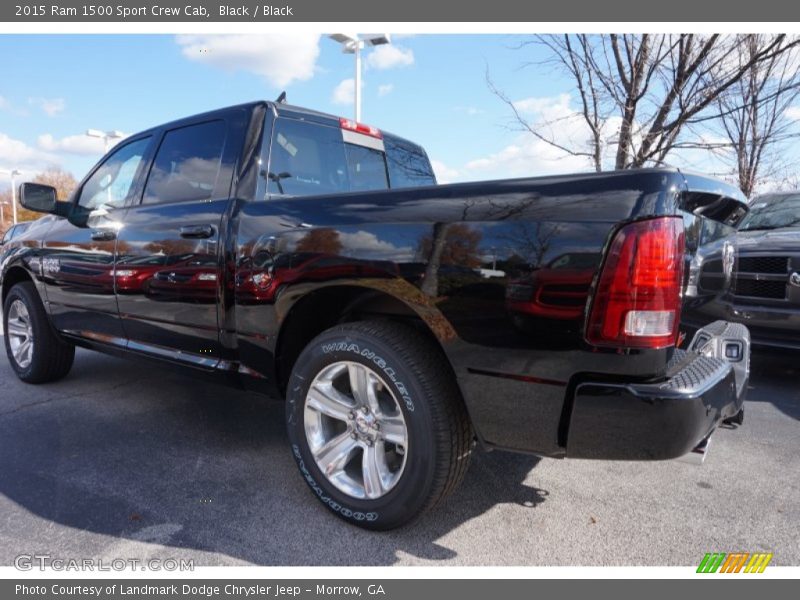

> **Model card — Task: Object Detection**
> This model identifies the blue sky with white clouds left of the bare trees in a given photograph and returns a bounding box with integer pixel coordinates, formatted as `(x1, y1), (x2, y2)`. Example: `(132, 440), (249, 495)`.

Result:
(0, 34), (588, 185)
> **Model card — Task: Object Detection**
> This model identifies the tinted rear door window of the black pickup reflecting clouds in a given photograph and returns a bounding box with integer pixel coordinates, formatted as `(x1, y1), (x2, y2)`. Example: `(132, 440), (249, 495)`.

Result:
(143, 121), (227, 204)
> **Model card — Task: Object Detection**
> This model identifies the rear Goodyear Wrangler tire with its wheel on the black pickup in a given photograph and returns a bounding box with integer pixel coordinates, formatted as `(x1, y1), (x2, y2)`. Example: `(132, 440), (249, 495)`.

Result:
(286, 321), (473, 530)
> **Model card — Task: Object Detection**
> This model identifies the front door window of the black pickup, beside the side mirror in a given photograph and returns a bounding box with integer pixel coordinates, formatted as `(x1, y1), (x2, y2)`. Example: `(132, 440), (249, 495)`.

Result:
(78, 137), (150, 210)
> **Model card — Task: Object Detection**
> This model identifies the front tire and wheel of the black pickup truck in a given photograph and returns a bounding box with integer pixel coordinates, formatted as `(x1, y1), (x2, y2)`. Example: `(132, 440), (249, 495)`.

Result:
(3, 281), (75, 383)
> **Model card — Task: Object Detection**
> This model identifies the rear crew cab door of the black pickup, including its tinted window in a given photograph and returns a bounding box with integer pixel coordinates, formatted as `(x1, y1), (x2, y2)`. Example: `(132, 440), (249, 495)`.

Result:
(115, 111), (246, 367)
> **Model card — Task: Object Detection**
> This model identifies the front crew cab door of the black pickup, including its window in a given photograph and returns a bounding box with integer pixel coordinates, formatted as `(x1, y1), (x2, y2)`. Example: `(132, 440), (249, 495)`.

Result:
(41, 135), (153, 345)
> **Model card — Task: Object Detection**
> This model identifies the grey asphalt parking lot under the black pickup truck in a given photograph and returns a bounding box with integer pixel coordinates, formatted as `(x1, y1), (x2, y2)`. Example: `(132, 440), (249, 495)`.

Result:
(0, 340), (800, 565)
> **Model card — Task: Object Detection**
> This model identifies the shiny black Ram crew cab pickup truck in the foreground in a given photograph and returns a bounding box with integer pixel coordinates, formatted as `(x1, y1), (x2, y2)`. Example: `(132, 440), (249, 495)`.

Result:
(0, 102), (750, 529)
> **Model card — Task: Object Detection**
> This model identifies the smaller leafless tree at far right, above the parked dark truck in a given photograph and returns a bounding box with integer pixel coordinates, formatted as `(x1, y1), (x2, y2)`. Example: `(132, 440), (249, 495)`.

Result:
(717, 34), (800, 197)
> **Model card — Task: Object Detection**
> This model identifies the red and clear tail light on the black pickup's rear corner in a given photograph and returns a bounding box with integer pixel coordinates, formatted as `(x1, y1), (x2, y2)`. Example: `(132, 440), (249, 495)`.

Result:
(586, 217), (684, 348)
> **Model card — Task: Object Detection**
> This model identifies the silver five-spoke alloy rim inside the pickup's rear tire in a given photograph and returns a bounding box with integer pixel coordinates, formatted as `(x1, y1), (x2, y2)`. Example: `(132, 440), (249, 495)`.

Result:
(303, 361), (408, 500)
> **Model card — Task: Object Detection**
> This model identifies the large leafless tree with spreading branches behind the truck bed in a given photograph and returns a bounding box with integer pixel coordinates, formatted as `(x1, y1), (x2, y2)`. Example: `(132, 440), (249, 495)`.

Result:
(487, 34), (800, 171)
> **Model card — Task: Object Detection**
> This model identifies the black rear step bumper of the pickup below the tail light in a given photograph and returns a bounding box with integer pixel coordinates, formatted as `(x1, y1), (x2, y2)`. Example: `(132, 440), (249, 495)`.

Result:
(567, 322), (750, 462)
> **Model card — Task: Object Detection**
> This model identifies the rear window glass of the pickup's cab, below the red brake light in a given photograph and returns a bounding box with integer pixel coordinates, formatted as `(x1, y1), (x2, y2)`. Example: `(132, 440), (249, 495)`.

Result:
(267, 118), (435, 196)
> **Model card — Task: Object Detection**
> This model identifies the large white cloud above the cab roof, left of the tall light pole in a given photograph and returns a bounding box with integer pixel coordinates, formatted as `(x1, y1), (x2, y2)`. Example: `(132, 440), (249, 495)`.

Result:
(176, 32), (320, 87)
